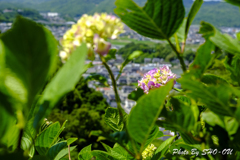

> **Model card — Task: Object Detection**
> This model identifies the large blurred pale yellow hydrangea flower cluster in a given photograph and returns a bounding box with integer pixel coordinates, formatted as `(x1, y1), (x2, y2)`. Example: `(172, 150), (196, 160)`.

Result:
(60, 13), (124, 61)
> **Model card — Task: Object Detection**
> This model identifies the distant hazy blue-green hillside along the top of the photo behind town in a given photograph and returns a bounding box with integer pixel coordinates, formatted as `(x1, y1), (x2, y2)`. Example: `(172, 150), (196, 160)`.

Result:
(0, 0), (240, 27)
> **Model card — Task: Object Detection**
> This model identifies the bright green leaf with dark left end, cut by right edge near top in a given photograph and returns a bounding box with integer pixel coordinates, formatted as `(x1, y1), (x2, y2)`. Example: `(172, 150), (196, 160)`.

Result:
(199, 22), (240, 55)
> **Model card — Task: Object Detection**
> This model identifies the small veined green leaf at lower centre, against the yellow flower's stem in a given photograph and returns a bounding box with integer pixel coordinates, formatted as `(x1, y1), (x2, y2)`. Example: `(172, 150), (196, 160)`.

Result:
(104, 107), (124, 132)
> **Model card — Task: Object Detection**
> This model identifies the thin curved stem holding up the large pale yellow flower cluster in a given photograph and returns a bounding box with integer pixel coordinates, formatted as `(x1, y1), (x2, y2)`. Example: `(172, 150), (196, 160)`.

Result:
(100, 56), (124, 118)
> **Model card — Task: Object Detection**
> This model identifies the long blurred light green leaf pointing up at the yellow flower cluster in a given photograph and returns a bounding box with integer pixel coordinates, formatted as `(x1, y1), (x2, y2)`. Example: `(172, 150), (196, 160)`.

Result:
(34, 44), (91, 127)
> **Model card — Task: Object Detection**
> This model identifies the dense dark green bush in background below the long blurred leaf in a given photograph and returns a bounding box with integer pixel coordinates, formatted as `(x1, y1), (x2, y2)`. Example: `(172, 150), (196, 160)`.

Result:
(48, 81), (113, 159)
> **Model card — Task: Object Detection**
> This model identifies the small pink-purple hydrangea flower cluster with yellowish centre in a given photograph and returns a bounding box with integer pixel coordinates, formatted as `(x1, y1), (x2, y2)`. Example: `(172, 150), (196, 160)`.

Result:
(138, 66), (176, 93)
